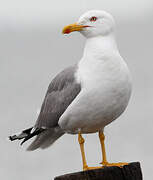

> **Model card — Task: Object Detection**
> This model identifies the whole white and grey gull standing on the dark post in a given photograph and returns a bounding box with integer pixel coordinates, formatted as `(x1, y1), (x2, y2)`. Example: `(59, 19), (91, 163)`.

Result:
(9, 10), (132, 170)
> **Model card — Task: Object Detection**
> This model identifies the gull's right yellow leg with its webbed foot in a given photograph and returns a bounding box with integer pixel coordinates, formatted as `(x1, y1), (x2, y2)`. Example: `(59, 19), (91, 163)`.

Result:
(99, 131), (128, 167)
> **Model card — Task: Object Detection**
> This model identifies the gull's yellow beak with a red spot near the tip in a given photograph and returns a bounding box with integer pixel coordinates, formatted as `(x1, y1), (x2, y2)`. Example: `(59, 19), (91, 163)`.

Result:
(62, 23), (89, 34)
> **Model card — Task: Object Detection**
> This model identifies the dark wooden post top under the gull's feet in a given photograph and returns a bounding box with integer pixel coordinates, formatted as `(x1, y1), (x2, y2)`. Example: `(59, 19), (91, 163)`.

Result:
(54, 162), (142, 180)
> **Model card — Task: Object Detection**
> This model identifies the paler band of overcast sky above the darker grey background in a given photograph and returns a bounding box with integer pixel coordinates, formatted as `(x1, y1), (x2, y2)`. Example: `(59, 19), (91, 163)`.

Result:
(0, 0), (153, 25)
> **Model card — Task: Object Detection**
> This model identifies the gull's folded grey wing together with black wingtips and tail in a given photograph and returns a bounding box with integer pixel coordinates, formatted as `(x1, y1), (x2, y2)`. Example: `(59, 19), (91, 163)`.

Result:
(10, 65), (81, 151)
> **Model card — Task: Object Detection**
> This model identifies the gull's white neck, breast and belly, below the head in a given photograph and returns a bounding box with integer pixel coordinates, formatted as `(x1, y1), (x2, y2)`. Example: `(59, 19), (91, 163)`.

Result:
(59, 33), (131, 133)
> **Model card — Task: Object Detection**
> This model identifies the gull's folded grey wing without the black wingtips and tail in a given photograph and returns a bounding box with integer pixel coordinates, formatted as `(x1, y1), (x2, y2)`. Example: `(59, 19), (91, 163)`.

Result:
(35, 65), (81, 129)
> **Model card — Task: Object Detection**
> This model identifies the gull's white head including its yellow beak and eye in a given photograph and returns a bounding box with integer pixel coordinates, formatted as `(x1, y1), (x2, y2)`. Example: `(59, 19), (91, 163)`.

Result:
(63, 10), (115, 38)
